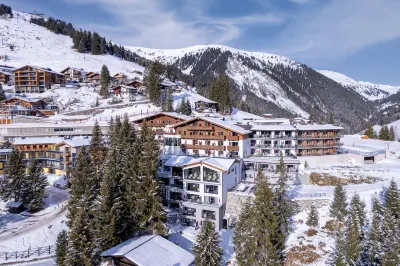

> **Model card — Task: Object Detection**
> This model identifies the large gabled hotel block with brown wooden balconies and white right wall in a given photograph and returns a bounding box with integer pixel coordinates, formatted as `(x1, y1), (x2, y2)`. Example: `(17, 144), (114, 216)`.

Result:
(168, 117), (251, 158)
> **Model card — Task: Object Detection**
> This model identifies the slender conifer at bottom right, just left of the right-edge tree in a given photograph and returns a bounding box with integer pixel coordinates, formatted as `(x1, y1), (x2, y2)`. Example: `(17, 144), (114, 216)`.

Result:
(367, 197), (383, 266)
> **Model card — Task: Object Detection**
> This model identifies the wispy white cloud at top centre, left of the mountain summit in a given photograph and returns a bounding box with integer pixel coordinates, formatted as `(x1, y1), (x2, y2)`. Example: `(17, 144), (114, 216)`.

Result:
(65, 0), (283, 48)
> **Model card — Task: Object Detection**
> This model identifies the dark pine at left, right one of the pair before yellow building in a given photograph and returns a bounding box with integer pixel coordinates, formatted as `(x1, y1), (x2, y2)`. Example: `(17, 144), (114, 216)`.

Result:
(26, 160), (48, 212)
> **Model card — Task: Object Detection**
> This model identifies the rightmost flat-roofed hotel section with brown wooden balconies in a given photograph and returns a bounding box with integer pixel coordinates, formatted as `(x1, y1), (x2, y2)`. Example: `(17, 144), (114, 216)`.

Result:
(296, 124), (343, 156)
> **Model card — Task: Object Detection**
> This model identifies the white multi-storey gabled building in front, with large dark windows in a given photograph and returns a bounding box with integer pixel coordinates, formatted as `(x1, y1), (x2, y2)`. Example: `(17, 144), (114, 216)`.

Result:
(159, 156), (241, 230)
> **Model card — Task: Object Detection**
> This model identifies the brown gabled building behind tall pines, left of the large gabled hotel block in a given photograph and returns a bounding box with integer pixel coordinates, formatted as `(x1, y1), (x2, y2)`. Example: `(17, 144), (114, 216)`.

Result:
(132, 112), (193, 142)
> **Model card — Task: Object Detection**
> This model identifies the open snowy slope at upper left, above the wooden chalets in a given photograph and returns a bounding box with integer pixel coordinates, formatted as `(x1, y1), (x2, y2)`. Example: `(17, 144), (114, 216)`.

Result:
(0, 12), (143, 75)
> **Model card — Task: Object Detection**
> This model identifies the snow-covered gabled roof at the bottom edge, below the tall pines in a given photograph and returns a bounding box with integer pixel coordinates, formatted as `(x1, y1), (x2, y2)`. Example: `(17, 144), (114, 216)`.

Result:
(101, 235), (194, 266)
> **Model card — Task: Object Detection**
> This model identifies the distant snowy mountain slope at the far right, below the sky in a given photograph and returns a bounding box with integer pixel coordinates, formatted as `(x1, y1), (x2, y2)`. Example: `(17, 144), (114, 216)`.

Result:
(318, 70), (400, 101)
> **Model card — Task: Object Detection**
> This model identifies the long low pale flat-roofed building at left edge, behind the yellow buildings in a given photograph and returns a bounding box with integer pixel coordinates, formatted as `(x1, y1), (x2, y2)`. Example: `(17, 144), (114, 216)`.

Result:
(0, 121), (109, 141)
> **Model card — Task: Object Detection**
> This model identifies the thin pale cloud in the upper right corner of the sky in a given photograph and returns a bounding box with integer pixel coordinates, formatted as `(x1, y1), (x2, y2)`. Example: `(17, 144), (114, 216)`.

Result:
(277, 0), (400, 61)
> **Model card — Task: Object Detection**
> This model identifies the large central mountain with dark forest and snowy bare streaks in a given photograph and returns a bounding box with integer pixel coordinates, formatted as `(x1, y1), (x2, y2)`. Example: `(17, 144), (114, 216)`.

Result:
(129, 45), (379, 132)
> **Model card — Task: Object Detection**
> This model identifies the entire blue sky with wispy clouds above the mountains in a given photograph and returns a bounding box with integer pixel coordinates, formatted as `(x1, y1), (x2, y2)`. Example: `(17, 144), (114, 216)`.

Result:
(5, 0), (400, 85)
